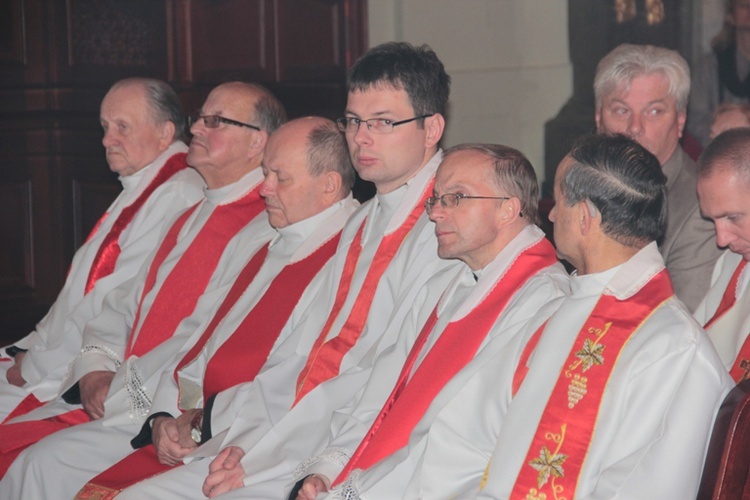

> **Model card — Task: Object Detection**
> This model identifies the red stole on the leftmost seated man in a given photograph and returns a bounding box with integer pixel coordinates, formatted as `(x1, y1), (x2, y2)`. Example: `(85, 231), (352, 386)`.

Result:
(84, 153), (188, 294)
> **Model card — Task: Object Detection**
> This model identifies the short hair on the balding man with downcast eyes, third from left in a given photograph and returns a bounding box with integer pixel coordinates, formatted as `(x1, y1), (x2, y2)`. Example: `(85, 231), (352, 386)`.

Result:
(307, 120), (355, 194)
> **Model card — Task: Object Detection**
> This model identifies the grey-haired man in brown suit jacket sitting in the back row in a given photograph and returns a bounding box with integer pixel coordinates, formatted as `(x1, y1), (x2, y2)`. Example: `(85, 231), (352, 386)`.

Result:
(594, 44), (720, 311)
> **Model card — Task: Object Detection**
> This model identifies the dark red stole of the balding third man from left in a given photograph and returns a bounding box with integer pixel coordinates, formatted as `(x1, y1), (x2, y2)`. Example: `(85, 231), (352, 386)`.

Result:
(78, 232), (341, 498)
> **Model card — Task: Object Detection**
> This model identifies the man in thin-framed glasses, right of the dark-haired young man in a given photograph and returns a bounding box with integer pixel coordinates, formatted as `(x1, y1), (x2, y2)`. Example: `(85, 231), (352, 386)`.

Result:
(297, 144), (568, 499)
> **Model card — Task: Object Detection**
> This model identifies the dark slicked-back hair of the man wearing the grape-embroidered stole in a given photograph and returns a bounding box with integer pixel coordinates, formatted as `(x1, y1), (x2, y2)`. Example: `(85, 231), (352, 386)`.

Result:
(560, 134), (667, 248)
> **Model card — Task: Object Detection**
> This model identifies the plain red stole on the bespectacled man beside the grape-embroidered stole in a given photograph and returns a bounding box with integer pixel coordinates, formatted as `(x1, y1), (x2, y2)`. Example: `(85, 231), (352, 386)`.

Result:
(333, 238), (557, 485)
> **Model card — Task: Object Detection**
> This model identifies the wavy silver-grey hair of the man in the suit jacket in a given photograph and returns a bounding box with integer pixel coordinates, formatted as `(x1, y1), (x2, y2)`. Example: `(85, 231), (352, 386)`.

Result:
(594, 43), (690, 112)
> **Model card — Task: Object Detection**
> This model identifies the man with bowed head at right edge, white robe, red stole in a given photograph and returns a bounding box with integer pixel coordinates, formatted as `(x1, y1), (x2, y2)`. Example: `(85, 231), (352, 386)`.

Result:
(695, 128), (750, 382)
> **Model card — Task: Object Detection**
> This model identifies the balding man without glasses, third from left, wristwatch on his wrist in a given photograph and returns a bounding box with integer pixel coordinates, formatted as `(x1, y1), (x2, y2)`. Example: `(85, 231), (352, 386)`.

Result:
(0, 118), (357, 496)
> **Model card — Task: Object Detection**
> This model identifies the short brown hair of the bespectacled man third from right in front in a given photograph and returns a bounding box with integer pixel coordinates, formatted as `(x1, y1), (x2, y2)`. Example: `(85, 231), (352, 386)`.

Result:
(443, 143), (540, 225)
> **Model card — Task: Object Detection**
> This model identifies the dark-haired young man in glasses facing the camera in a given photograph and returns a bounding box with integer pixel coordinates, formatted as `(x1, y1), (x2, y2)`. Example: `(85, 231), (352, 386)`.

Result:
(96, 43), (464, 497)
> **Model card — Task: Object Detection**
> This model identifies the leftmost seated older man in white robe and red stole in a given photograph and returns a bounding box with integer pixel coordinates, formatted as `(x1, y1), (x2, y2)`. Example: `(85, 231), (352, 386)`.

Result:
(0, 78), (203, 421)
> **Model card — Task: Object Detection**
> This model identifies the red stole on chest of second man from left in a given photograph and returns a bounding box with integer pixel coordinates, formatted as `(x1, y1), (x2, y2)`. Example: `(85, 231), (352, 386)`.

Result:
(126, 186), (265, 358)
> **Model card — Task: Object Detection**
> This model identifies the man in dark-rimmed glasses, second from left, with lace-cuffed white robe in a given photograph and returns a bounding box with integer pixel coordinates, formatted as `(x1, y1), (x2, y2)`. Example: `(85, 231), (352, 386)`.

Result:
(0, 82), (286, 480)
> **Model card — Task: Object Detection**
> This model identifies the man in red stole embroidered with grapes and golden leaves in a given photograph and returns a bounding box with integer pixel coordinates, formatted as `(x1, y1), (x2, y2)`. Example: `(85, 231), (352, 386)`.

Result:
(472, 136), (732, 500)
